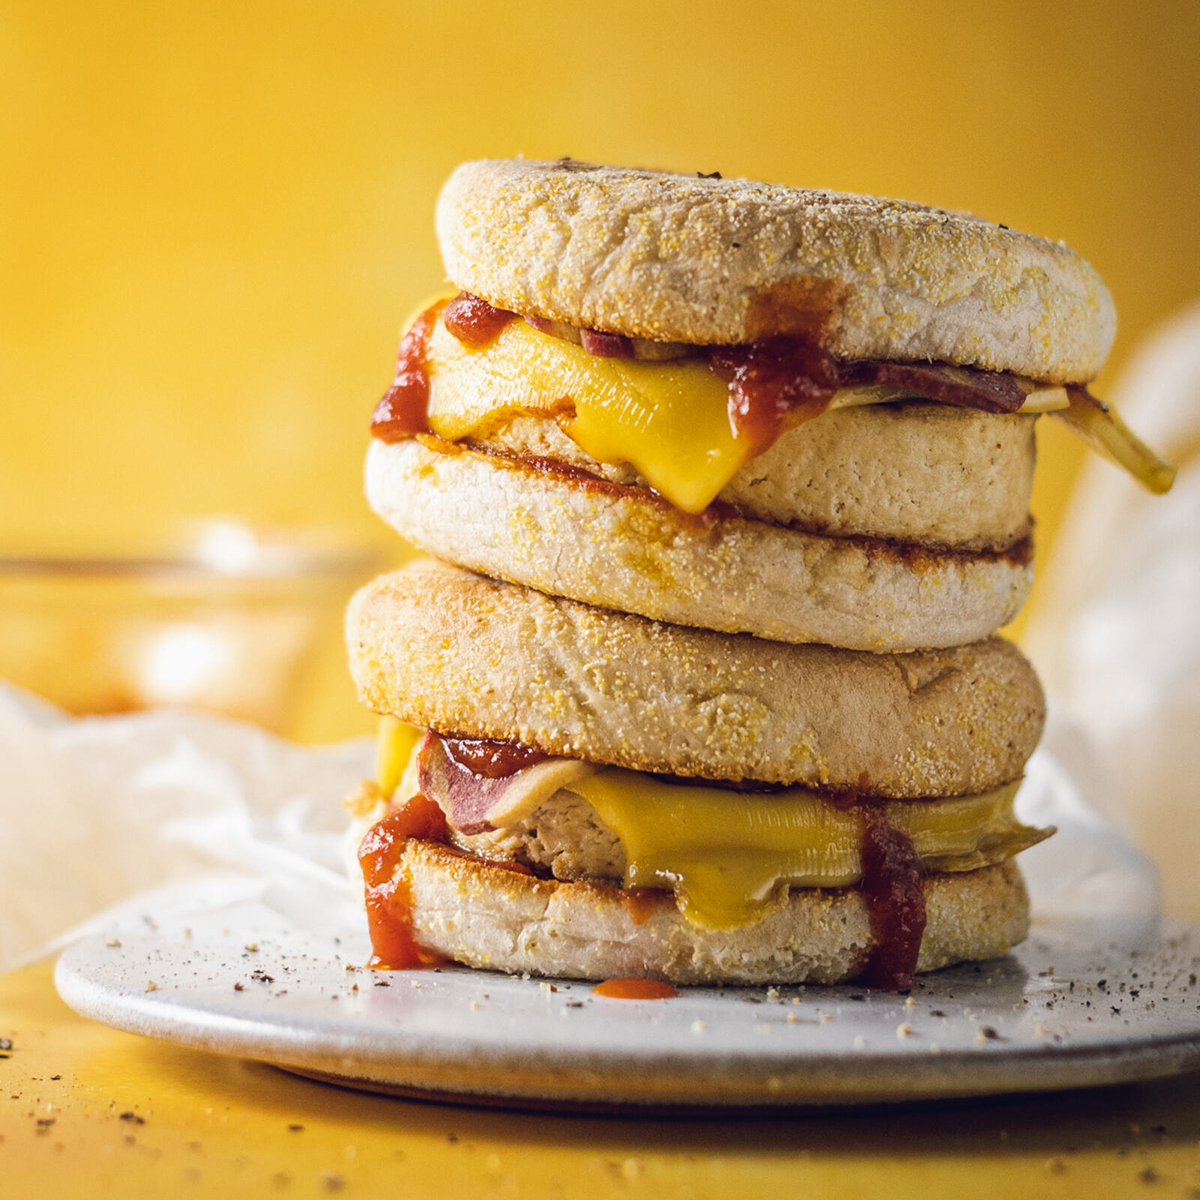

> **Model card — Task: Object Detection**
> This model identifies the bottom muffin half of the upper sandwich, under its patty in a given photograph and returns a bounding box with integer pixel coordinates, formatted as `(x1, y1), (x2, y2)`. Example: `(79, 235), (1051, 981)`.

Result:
(366, 438), (1033, 653)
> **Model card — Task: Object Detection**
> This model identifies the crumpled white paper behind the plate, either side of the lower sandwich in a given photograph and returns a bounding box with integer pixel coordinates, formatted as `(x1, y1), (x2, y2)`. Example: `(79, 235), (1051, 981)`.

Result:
(0, 685), (1158, 970)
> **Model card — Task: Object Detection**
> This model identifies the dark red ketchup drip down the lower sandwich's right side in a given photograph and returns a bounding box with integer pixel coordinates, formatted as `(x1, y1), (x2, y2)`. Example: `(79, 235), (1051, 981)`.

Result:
(857, 804), (925, 991)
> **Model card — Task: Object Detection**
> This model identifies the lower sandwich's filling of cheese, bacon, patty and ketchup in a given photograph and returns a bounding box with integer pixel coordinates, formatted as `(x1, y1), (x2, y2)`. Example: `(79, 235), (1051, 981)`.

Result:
(356, 721), (1049, 985)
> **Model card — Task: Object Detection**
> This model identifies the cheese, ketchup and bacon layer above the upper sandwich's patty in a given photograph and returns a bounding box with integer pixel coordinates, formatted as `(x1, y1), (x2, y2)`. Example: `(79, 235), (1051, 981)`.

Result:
(372, 293), (1170, 512)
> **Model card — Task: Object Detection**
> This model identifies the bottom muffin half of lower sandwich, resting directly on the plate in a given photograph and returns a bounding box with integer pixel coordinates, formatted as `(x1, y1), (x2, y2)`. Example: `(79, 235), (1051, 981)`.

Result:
(388, 839), (1030, 984)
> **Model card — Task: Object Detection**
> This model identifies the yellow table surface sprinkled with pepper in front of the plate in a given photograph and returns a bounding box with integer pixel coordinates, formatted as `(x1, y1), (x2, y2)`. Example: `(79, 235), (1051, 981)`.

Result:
(0, 964), (1200, 1200)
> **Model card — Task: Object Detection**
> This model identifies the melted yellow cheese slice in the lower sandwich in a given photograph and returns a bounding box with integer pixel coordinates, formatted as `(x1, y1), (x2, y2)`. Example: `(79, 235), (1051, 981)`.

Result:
(569, 768), (1052, 929)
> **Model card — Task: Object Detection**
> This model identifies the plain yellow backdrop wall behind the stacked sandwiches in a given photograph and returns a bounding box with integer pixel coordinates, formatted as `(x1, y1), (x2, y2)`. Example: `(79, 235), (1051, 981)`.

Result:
(0, 0), (1200, 737)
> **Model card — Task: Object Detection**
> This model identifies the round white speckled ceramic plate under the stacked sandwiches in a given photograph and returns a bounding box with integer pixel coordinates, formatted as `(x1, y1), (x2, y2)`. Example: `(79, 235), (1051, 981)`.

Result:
(56, 902), (1200, 1108)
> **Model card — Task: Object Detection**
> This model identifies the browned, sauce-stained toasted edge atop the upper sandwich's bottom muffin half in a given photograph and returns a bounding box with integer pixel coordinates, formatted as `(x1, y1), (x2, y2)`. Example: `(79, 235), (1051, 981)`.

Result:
(416, 433), (1033, 561)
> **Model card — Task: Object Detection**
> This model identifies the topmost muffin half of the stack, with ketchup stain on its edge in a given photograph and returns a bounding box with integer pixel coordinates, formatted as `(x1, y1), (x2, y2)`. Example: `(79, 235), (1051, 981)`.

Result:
(437, 160), (1116, 383)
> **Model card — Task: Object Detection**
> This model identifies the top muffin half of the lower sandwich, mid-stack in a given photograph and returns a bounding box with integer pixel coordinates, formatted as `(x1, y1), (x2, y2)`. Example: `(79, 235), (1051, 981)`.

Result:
(347, 563), (1045, 798)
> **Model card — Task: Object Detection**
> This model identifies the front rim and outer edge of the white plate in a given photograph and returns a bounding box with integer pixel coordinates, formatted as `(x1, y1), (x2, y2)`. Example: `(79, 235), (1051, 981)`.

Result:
(55, 930), (1200, 1109)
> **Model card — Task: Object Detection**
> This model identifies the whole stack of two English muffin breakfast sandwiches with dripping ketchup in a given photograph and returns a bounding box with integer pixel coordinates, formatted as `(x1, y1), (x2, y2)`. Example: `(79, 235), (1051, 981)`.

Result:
(348, 160), (1170, 989)
